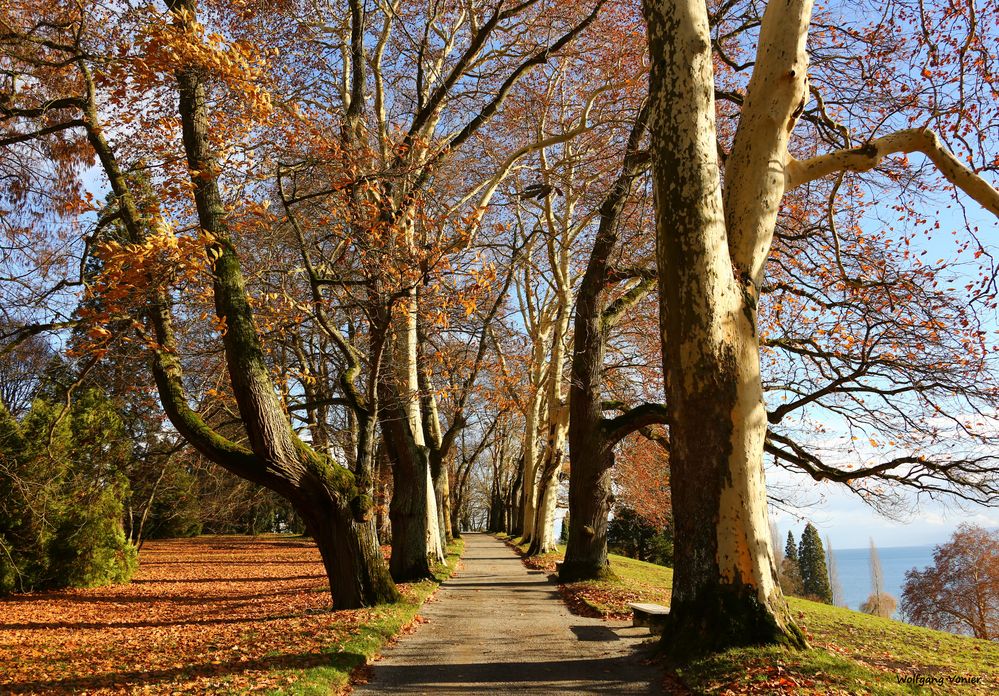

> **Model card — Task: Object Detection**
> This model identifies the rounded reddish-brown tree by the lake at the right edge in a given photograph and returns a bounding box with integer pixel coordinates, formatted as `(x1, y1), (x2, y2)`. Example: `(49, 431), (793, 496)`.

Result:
(901, 525), (999, 640)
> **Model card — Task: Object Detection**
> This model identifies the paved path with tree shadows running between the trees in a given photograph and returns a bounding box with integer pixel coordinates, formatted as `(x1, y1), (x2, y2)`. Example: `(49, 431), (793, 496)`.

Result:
(356, 534), (662, 696)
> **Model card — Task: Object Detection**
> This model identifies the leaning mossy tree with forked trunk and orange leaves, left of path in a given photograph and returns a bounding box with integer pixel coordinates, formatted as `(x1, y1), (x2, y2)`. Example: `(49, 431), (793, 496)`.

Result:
(0, 0), (398, 607)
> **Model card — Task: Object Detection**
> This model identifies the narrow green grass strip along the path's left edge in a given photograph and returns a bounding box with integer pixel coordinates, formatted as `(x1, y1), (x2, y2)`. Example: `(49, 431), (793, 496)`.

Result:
(270, 539), (464, 696)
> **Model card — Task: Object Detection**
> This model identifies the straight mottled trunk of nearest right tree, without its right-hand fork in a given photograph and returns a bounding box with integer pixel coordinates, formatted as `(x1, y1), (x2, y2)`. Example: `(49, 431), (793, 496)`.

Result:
(644, 0), (805, 660)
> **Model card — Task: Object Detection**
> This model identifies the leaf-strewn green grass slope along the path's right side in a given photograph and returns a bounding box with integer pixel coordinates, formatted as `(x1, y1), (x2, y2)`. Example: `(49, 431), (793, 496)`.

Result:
(500, 539), (999, 694)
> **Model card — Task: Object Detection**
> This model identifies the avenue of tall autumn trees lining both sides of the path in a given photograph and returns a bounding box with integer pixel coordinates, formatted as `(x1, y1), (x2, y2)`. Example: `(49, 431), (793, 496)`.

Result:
(0, 0), (999, 658)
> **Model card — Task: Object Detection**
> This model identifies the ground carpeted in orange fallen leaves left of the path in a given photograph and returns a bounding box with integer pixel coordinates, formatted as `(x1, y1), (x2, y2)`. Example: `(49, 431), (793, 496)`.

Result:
(0, 536), (458, 694)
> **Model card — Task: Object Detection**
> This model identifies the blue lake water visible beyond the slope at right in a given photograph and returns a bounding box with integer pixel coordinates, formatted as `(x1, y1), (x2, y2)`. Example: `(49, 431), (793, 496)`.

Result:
(833, 546), (933, 618)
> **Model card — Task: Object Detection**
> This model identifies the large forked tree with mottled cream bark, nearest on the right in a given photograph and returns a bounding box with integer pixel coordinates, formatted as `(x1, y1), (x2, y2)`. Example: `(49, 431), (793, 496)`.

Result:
(643, 0), (999, 657)
